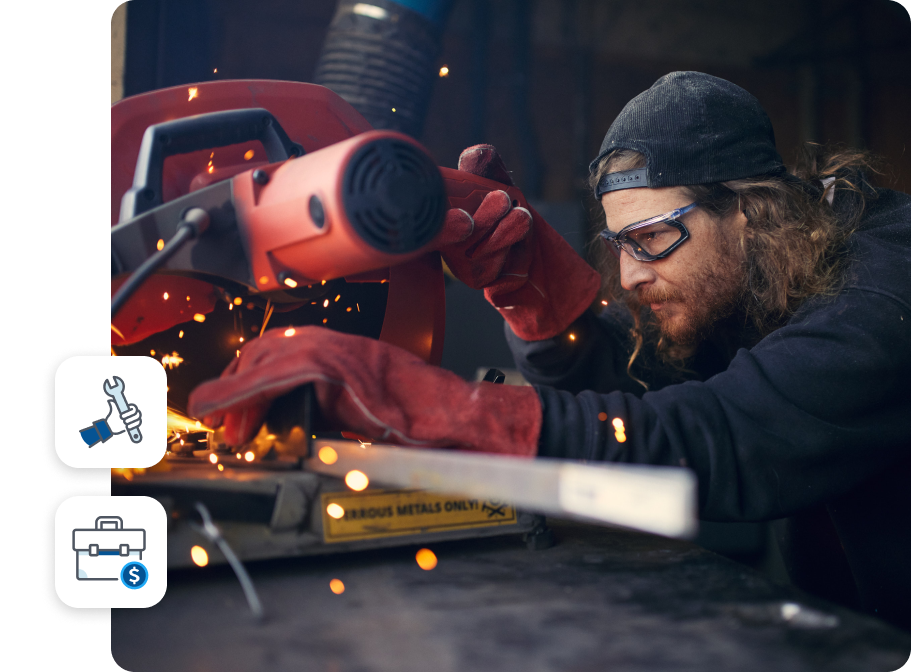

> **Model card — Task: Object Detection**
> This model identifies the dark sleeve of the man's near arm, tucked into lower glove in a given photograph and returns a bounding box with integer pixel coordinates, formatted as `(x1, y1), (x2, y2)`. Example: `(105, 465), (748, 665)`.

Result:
(525, 289), (911, 520)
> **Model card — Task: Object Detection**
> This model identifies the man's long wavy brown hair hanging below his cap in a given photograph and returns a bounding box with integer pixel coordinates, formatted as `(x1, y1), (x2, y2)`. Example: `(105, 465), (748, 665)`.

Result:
(589, 143), (879, 389)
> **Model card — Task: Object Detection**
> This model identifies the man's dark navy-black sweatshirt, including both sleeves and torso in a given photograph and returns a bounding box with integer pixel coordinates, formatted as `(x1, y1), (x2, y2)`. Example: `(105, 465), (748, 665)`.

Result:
(506, 185), (911, 627)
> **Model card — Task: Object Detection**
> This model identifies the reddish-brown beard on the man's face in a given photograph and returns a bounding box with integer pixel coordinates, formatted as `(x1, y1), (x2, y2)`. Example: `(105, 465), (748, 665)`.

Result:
(636, 241), (745, 348)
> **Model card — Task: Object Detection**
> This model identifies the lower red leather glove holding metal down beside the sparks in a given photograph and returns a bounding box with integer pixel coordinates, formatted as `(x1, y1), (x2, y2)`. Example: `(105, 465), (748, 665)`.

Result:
(189, 327), (542, 457)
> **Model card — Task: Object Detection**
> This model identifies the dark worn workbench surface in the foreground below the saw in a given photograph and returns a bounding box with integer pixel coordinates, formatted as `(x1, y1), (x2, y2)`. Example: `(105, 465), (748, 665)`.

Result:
(111, 520), (911, 672)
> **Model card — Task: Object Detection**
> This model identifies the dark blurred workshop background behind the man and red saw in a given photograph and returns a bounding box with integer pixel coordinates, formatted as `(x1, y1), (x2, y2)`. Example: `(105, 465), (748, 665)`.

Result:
(111, 0), (911, 578)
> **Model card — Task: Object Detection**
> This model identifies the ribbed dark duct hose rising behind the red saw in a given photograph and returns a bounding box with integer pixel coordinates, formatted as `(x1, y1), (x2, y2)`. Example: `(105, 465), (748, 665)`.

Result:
(313, 0), (452, 138)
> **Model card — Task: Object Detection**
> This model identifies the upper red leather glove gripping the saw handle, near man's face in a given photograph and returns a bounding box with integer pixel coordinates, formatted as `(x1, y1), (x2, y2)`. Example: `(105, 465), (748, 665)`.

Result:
(438, 145), (601, 341)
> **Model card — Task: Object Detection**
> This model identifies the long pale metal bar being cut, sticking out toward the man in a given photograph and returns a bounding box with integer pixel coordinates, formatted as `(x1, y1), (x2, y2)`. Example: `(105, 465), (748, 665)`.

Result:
(306, 440), (698, 538)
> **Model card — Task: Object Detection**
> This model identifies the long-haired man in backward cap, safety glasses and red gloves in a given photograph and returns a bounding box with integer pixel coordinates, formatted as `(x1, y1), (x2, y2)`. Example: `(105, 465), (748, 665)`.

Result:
(191, 72), (911, 627)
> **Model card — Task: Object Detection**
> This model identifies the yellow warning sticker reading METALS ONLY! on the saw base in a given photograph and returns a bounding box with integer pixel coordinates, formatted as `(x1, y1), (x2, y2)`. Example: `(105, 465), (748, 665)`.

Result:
(321, 490), (516, 543)
